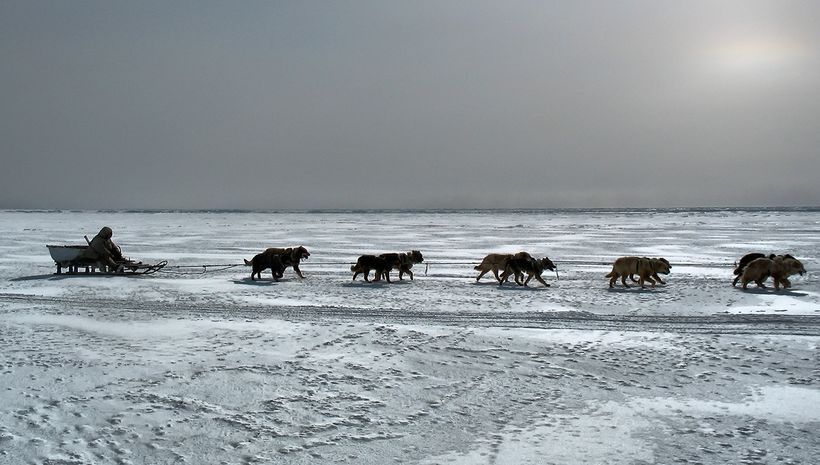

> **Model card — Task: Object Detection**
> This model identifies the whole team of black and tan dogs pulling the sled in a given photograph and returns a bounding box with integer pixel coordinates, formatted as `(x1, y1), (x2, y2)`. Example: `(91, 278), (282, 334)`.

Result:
(240, 246), (806, 290)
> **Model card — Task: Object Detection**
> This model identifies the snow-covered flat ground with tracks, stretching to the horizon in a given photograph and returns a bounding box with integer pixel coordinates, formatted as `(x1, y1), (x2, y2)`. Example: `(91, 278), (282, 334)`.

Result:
(0, 210), (820, 464)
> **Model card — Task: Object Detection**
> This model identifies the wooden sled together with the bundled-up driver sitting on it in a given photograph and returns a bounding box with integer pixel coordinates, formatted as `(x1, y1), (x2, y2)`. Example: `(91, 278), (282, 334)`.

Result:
(46, 226), (168, 275)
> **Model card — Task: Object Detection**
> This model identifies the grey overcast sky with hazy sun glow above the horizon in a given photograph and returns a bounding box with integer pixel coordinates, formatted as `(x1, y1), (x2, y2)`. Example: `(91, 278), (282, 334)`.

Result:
(0, 0), (820, 209)
